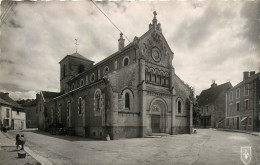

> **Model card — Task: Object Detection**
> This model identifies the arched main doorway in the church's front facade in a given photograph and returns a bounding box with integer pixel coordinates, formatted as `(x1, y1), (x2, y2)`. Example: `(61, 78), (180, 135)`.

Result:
(150, 98), (167, 133)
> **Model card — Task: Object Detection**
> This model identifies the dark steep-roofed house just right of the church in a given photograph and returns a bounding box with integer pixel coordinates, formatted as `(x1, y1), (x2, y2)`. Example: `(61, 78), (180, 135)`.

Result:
(197, 81), (232, 128)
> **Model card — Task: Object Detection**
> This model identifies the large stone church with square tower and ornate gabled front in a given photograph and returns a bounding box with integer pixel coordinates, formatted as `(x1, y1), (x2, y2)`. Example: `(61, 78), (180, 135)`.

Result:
(38, 12), (193, 139)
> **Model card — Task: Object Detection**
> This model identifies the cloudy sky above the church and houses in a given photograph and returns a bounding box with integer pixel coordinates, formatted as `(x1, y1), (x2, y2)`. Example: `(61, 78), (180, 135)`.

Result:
(0, 1), (260, 100)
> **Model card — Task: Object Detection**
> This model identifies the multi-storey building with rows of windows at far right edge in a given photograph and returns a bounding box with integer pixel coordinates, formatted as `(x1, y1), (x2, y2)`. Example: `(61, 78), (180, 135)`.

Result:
(226, 71), (260, 131)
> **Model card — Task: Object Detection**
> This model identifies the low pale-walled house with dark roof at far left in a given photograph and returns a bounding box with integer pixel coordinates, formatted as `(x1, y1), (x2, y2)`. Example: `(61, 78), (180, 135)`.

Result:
(0, 92), (26, 130)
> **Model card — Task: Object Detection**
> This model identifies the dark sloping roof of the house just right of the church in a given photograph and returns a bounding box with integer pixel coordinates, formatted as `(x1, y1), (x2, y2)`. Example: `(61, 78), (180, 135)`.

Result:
(197, 82), (232, 106)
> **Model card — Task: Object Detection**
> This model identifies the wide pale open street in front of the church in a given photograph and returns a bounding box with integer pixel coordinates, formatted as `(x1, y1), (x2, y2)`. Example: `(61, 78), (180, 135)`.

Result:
(4, 129), (260, 165)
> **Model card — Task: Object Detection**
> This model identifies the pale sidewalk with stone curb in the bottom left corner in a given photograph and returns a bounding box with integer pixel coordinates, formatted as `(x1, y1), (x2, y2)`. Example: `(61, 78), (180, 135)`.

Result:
(0, 132), (41, 165)
